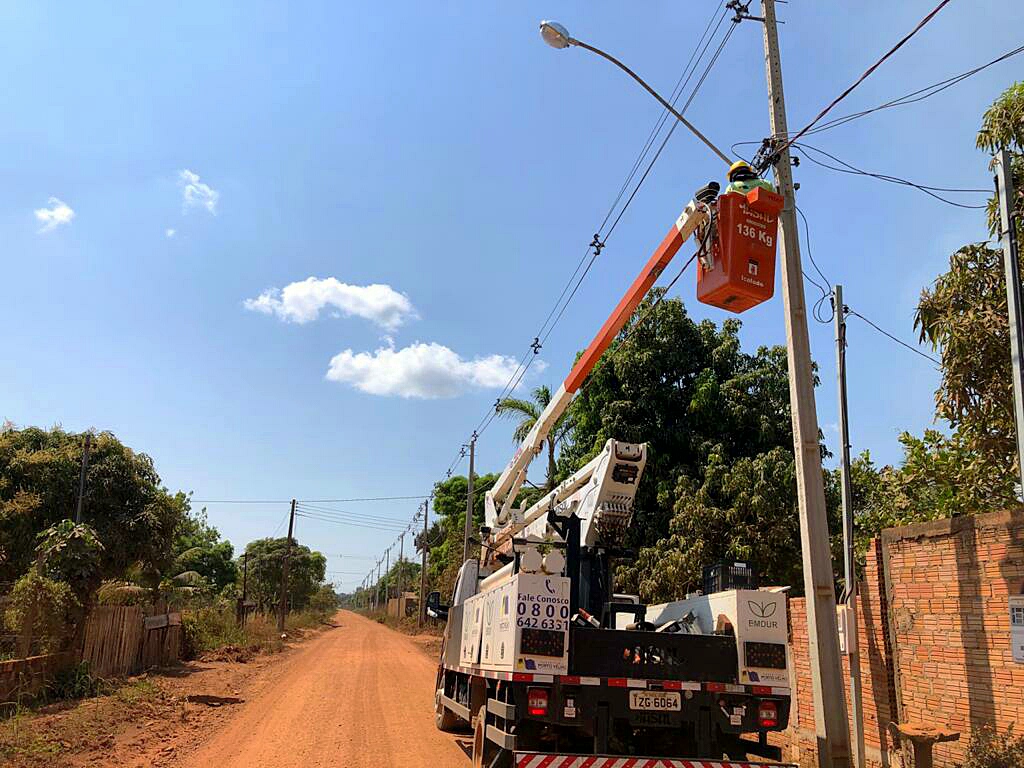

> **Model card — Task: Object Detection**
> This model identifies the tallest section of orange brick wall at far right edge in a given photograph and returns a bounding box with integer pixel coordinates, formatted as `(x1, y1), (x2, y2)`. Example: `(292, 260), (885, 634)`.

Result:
(882, 510), (1024, 766)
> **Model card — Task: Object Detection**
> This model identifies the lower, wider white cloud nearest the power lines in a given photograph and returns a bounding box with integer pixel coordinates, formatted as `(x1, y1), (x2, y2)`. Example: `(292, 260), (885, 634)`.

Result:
(327, 342), (544, 399)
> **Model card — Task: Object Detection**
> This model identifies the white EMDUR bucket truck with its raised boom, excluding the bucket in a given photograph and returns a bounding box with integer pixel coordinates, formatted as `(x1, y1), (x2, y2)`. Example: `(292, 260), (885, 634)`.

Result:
(427, 193), (791, 768)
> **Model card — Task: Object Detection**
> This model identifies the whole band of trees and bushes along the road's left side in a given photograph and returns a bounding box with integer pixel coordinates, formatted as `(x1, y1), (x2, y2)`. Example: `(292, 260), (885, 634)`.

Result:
(0, 423), (338, 714)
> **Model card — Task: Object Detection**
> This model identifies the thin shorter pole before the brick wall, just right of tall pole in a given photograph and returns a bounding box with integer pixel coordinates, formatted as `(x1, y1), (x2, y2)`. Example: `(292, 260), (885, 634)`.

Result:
(833, 286), (864, 768)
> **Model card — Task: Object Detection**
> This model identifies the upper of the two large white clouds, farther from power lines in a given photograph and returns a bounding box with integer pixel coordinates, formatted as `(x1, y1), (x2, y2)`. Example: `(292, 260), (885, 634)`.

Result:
(244, 278), (416, 331)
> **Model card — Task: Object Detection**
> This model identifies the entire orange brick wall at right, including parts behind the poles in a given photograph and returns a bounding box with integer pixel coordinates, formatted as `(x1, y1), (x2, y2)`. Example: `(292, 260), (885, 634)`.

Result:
(784, 510), (1024, 768)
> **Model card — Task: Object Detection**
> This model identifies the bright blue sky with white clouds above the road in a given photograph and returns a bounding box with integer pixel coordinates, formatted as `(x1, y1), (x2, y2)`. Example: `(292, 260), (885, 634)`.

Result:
(0, 0), (1024, 587)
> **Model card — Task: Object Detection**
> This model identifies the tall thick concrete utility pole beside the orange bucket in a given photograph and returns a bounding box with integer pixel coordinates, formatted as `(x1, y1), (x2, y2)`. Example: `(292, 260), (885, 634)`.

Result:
(761, 0), (850, 768)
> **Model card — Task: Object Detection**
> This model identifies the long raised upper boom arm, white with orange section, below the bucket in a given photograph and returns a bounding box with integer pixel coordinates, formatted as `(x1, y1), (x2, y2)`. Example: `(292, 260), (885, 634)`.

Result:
(484, 201), (709, 531)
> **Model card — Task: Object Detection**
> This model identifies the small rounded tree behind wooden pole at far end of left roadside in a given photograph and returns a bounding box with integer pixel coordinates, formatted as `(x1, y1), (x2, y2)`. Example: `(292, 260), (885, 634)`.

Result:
(246, 537), (327, 611)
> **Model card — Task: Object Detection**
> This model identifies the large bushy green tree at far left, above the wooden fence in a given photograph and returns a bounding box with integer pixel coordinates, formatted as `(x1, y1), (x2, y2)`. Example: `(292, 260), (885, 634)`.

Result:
(0, 425), (188, 582)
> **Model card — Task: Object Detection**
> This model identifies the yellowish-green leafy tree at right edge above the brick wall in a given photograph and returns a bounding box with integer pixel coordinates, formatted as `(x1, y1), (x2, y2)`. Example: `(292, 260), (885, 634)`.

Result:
(901, 83), (1024, 518)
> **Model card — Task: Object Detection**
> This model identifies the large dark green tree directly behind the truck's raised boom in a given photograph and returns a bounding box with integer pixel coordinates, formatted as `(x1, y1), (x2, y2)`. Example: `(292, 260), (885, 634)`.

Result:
(559, 290), (793, 550)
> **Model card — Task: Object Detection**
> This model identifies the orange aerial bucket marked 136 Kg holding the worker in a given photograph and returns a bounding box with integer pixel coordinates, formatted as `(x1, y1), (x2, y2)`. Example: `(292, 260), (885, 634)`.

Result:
(697, 187), (783, 313)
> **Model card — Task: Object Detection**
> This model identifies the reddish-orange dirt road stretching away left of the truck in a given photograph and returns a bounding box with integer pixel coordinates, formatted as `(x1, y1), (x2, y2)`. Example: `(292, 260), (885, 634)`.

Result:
(179, 611), (469, 768)
